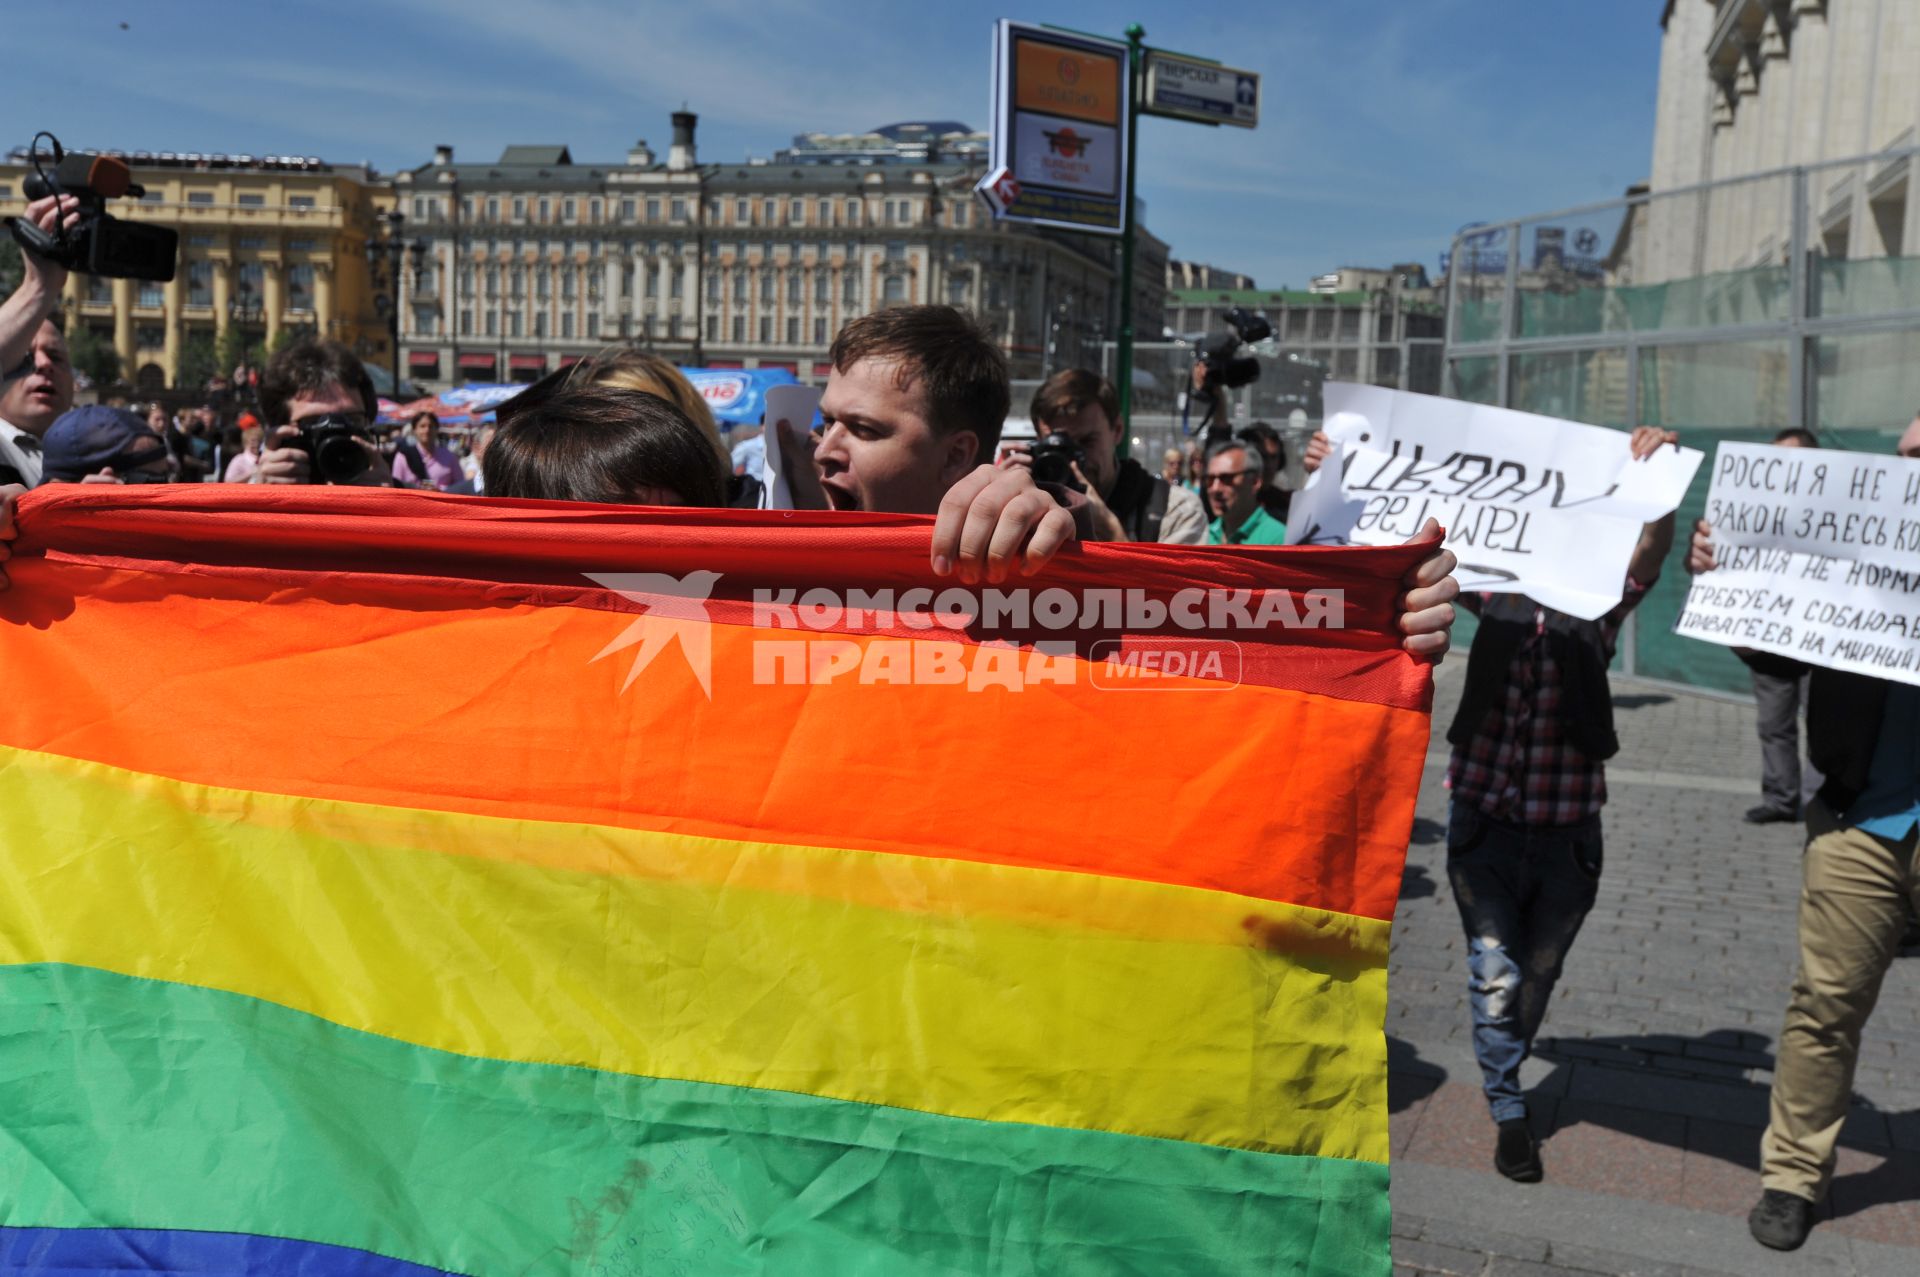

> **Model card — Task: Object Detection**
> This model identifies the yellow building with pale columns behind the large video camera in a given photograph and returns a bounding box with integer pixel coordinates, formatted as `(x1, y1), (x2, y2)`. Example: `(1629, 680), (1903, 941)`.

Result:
(0, 152), (388, 392)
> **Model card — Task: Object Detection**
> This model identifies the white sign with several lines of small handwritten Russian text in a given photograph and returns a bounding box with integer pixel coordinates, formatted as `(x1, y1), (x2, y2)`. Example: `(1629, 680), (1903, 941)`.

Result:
(1674, 444), (1920, 684)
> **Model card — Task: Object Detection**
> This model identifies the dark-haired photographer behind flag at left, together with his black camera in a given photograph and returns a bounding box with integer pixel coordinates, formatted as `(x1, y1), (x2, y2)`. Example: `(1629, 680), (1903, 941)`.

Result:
(248, 338), (394, 488)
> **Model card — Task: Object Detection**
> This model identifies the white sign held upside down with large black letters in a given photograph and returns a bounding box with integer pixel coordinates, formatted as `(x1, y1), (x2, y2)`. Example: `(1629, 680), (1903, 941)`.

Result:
(1286, 382), (1703, 620)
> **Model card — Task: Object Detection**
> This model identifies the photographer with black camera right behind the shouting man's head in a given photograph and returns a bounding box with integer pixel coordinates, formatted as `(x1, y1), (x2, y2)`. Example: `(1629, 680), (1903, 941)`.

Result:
(1000, 369), (1206, 545)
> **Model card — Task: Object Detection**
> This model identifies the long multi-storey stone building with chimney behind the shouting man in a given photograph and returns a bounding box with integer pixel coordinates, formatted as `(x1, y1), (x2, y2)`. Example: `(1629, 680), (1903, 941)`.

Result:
(394, 111), (1165, 388)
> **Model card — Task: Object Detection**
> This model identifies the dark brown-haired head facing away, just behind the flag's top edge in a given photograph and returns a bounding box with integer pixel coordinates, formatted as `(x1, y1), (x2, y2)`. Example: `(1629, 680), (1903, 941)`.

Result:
(480, 382), (726, 507)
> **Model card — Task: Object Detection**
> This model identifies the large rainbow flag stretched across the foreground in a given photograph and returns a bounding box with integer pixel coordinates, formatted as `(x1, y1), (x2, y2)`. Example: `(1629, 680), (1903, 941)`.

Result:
(0, 486), (1430, 1277)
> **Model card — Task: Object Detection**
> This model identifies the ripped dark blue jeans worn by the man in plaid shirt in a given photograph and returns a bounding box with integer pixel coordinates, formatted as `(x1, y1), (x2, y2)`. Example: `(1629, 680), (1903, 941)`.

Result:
(1446, 799), (1601, 1121)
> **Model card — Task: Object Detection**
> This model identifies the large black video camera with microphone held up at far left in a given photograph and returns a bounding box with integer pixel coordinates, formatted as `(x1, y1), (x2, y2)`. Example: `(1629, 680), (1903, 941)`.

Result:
(8, 133), (180, 282)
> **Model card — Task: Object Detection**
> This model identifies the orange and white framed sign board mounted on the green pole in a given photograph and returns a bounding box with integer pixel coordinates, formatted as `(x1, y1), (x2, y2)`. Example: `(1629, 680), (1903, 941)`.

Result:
(981, 19), (1133, 234)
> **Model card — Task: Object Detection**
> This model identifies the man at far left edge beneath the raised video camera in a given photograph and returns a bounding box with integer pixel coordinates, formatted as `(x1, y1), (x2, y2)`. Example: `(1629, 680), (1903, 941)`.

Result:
(0, 196), (79, 488)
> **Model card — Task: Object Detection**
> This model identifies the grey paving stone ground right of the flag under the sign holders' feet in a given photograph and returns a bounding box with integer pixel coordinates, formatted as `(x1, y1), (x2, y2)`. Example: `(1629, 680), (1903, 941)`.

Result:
(1386, 661), (1920, 1277)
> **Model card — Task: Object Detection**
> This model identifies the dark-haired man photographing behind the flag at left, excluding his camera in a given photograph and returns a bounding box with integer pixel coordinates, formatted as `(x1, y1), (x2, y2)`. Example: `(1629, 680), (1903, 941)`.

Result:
(248, 338), (394, 486)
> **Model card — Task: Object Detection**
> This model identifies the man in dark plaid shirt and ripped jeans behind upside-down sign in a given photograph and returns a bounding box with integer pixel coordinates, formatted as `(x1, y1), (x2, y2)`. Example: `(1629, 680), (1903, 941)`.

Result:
(1448, 426), (1678, 1183)
